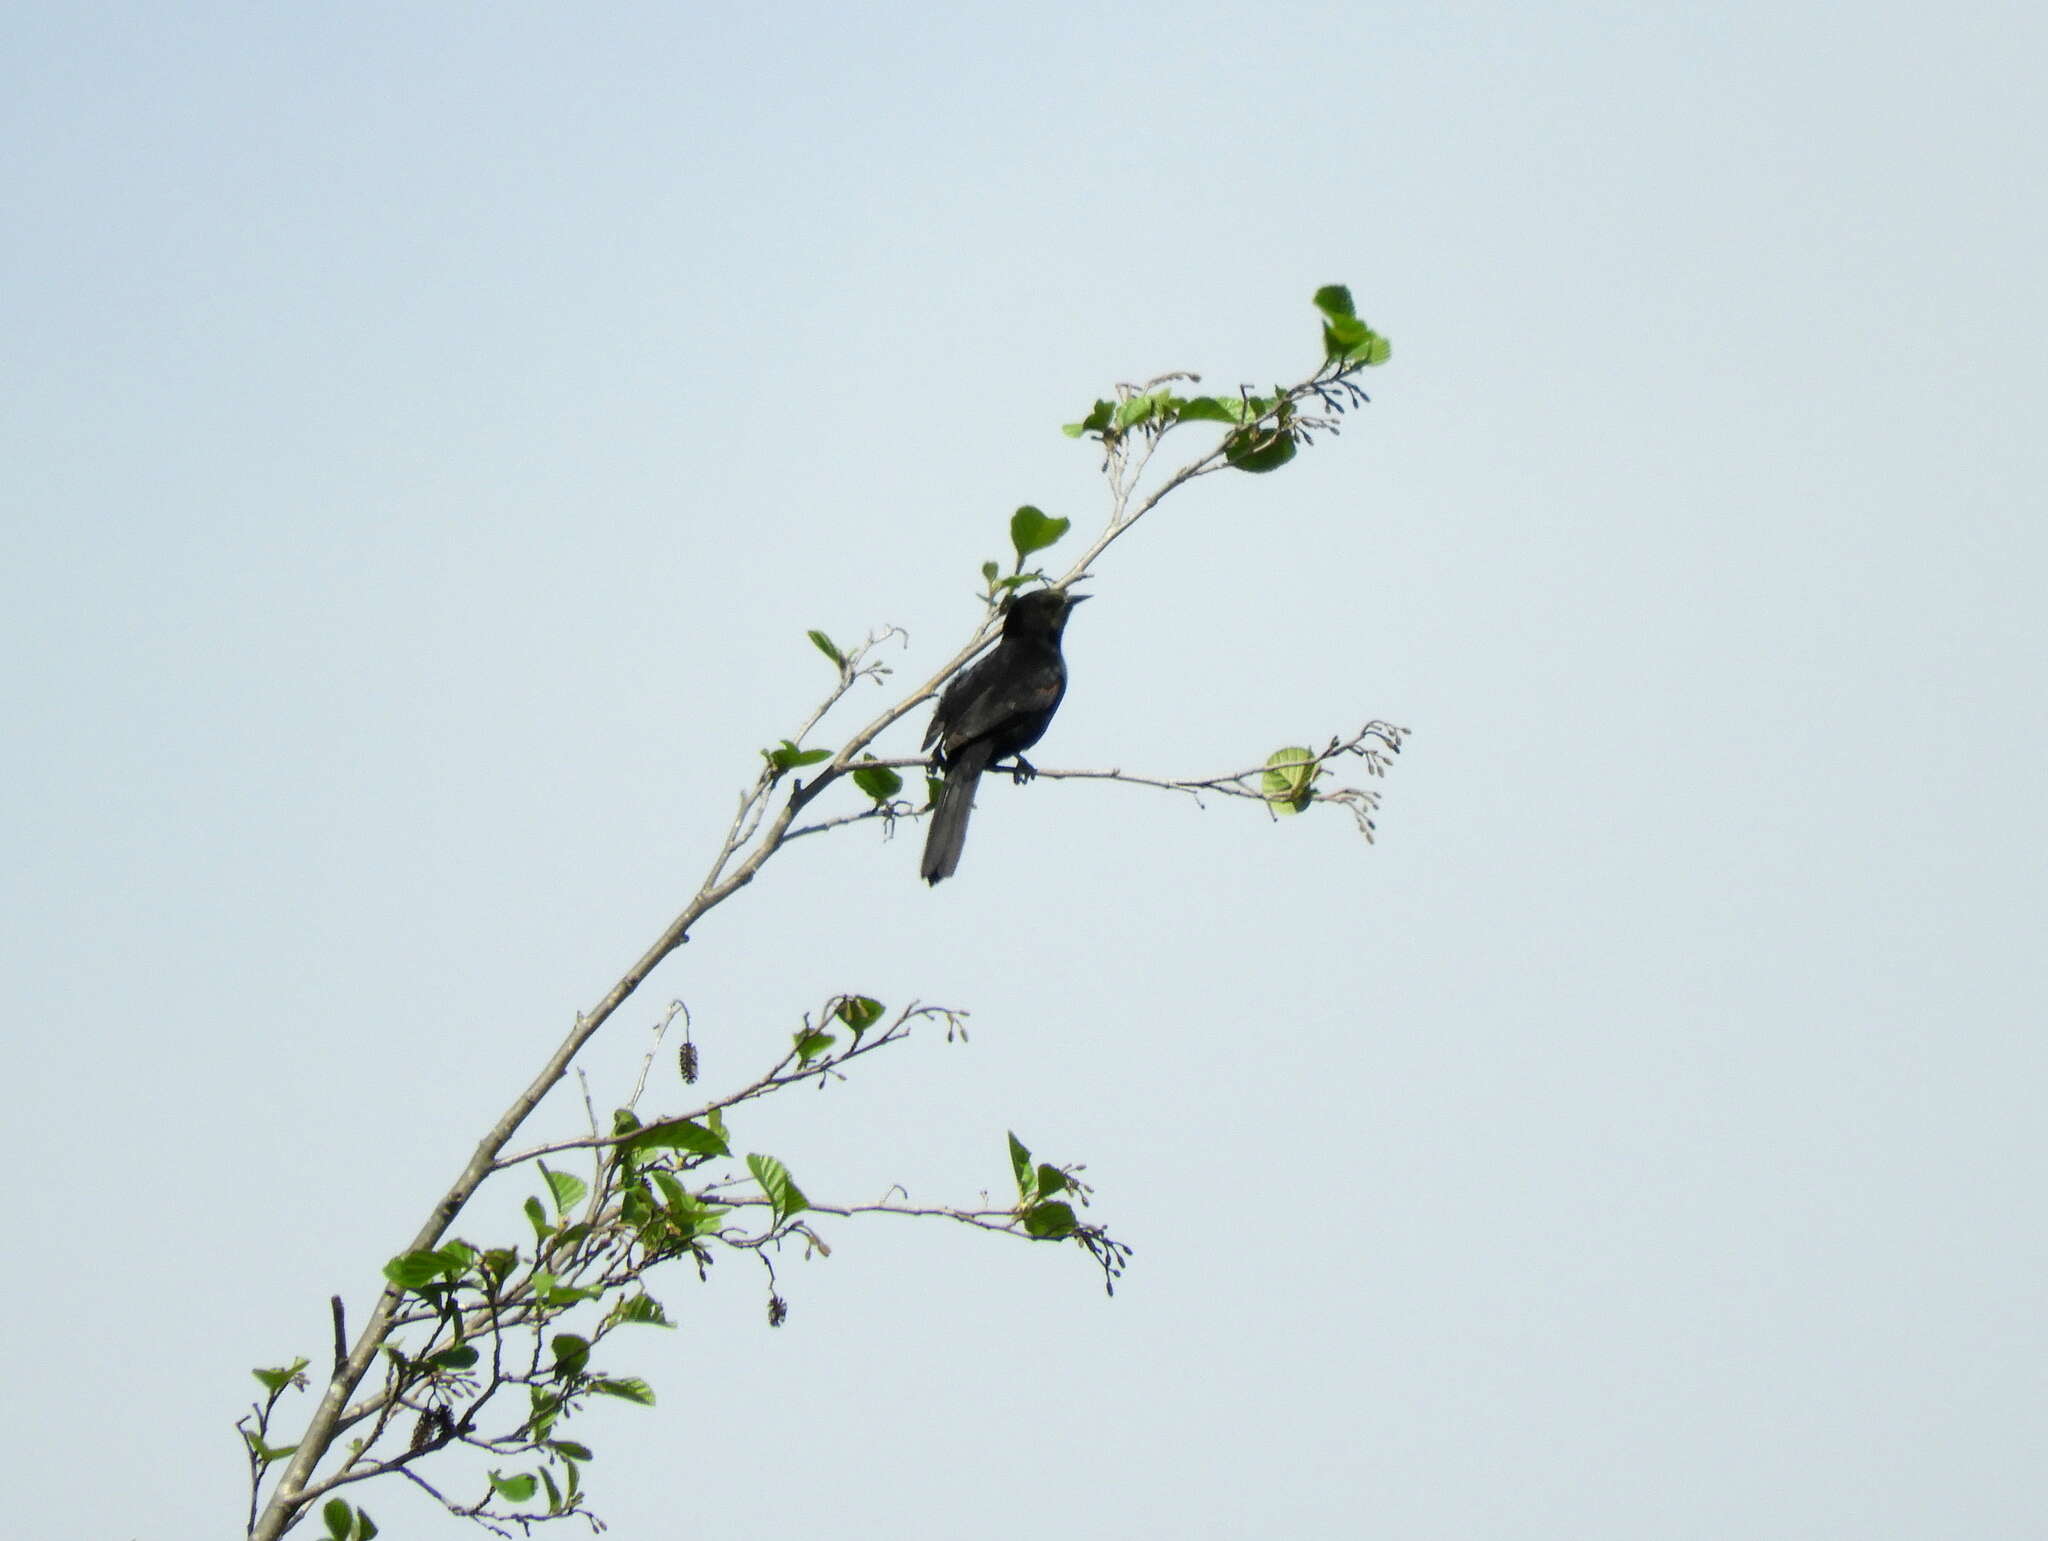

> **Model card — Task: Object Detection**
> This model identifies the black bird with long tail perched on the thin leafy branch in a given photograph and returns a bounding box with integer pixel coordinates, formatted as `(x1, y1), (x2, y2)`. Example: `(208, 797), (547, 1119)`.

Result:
(920, 588), (1090, 883)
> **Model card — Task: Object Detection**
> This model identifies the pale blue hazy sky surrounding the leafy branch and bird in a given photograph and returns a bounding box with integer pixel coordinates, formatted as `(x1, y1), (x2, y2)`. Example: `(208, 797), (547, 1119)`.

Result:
(0, 0), (2048, 1541)
